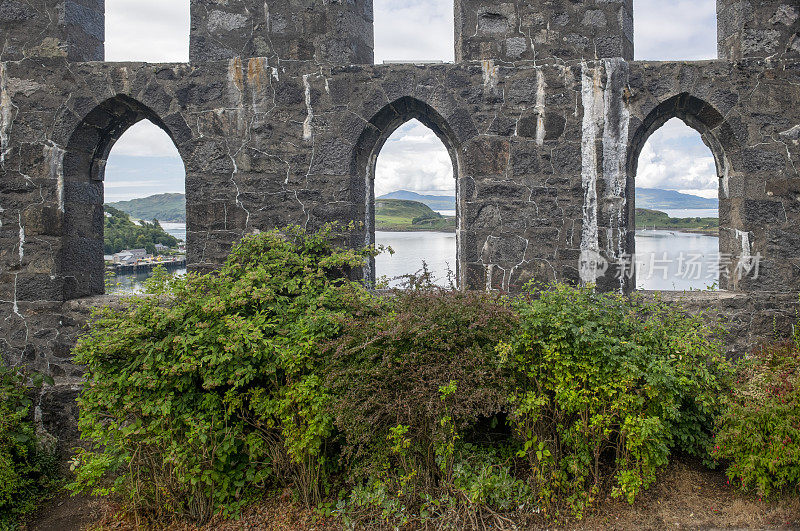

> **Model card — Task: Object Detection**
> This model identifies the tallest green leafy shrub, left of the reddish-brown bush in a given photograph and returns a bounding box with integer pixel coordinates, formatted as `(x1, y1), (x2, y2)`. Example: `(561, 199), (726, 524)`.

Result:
(72, 227), (382, 520)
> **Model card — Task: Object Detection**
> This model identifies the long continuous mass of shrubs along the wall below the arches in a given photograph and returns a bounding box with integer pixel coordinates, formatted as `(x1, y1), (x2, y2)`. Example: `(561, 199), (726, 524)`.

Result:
(73, 227), (726, 528)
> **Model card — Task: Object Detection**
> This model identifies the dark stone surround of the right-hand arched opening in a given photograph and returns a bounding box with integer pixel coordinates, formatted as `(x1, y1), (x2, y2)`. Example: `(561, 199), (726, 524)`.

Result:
(625, 92), (742, 290)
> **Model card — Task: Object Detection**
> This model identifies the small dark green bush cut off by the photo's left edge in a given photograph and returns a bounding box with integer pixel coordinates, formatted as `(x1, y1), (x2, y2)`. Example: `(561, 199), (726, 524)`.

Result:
(0, 360), (56, 529)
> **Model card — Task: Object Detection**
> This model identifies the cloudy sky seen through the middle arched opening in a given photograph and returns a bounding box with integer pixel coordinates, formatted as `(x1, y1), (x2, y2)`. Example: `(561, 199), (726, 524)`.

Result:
(375, 120), (456, 196)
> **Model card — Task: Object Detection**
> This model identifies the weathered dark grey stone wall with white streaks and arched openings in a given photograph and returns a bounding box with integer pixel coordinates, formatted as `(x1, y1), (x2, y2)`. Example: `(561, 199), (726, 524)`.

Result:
(0, 0), (800, 440)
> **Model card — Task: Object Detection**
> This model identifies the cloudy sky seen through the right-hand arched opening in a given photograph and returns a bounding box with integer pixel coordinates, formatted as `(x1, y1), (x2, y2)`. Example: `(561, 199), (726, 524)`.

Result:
(636, 118), (719, 197)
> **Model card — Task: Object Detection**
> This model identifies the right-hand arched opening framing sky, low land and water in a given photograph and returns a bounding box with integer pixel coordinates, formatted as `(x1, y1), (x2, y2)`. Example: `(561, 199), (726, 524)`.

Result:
(635, 118), (725, 291)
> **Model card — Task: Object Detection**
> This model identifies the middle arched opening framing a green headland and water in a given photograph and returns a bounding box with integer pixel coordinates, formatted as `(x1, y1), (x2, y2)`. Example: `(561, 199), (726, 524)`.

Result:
(374, 120), (456, 286)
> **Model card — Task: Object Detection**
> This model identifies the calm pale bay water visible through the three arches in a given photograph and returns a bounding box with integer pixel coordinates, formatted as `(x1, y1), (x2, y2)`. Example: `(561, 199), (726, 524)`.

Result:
(107, 222), (719, 293)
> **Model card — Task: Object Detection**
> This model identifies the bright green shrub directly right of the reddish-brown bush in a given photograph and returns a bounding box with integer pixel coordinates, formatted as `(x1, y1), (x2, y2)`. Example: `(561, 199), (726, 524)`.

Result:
(499, 285), (726, 515)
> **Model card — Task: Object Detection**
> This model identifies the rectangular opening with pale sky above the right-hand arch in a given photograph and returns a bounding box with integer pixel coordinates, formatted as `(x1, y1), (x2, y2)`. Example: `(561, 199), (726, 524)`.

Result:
(633, 0), (717, 61)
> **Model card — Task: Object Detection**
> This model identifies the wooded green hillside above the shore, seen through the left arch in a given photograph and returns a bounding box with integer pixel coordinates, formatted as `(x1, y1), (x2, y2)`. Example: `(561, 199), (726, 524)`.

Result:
(103, 205), (178, 254)
